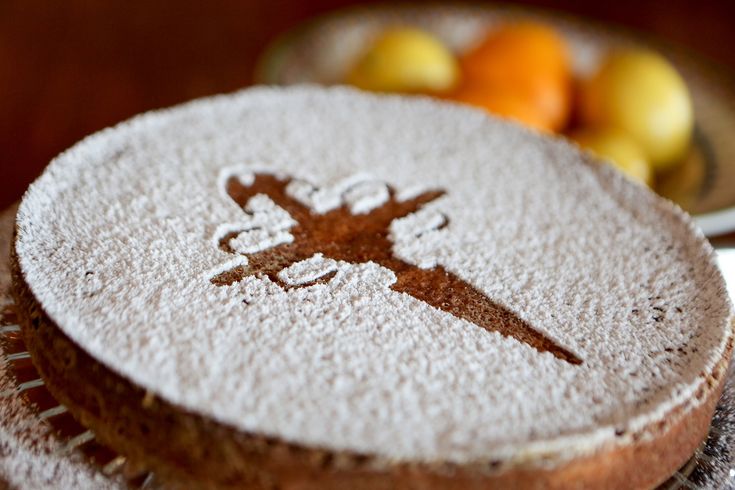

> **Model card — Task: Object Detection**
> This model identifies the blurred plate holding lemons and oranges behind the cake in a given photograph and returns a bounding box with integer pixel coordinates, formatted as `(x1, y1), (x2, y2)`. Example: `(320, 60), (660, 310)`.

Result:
(256, 4), (735, 236)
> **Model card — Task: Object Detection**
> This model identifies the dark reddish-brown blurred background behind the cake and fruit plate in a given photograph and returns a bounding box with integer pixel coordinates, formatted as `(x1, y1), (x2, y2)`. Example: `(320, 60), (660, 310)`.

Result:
(0, 0), (735, 243)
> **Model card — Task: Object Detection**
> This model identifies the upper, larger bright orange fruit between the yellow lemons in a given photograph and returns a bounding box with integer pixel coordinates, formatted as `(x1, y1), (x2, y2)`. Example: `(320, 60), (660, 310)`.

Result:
(461, 22), (571, 131)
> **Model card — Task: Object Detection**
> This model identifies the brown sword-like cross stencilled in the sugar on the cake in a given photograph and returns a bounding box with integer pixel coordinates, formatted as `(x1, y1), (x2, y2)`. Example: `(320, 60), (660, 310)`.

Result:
(211, 173), (582, 364)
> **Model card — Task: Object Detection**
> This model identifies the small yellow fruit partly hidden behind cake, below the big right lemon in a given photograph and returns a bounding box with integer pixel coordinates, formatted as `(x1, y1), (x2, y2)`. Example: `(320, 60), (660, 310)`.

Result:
(570, 127), (653, 185)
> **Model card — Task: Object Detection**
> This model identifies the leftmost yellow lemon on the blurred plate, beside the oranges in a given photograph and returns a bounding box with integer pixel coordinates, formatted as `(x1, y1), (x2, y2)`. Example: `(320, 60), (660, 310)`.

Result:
(347, 28), (459, 92)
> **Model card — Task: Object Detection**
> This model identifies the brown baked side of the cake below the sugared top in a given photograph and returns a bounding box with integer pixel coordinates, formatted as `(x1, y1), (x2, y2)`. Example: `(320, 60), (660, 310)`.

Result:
(10, 236), (734, 489)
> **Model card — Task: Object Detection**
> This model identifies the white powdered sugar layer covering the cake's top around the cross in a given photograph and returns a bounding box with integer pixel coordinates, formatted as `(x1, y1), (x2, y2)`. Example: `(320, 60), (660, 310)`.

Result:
(16, 87), (731, 465)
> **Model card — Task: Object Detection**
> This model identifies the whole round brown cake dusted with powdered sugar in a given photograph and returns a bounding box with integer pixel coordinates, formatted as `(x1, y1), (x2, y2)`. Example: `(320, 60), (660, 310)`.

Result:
(12, 87), (732, 488)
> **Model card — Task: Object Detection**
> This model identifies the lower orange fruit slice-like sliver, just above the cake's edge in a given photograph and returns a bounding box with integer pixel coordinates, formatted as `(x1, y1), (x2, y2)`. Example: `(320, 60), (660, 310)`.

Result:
(451, 87), (552, 132)
